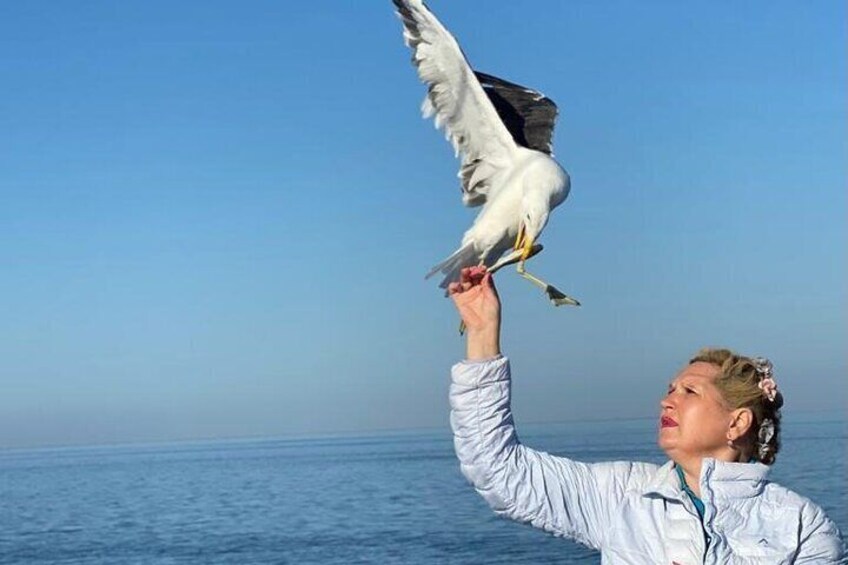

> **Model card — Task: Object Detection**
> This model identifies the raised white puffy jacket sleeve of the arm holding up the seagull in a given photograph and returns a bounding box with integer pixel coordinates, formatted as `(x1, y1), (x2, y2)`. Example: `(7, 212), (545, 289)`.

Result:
(450, 357), (633, 549)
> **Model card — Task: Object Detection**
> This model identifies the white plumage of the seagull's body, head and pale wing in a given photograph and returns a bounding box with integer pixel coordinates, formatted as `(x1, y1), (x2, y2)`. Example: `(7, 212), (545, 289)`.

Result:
(393, 0), (570, 287)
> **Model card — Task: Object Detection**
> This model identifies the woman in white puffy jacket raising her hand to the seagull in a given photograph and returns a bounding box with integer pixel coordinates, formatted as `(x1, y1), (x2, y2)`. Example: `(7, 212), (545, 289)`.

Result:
(448, 268), (848, 565)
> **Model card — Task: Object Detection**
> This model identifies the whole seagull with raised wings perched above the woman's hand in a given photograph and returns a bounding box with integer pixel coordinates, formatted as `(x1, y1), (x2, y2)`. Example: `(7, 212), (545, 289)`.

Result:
(392, 0), (580, 306)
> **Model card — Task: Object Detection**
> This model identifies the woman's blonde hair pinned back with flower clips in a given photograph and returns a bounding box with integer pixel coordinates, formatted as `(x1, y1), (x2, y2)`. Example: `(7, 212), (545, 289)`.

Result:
(689, 348), (783, 465)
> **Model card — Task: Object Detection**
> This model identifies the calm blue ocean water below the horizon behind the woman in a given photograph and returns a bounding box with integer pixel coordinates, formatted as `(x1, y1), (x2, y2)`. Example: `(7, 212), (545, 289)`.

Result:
(0, 418), (848, 564)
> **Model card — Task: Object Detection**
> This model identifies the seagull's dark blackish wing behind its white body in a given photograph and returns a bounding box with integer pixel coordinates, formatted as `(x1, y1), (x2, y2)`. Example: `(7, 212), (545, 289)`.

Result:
(474, 71), (557, 155)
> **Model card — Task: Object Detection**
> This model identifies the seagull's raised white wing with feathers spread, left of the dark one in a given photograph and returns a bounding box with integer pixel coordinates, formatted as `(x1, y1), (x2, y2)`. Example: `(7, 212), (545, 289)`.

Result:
(392, 0), (517, 206)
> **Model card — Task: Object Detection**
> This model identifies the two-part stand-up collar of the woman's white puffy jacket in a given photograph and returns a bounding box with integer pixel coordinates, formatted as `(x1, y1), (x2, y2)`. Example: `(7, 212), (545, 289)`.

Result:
(642, 458), (769, 500)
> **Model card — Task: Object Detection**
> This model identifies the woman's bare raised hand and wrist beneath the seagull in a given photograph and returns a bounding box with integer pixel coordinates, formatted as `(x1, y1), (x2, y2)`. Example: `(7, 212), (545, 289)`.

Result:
(448, 267), (501, 360)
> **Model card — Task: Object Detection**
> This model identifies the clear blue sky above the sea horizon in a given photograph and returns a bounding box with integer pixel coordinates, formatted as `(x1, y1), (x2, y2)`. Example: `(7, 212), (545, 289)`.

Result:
(0, 0), (848, 447)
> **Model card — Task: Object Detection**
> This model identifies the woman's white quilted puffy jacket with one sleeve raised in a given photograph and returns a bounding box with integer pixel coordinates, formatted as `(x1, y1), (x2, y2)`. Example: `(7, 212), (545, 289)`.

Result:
(450, 357), (848, 565)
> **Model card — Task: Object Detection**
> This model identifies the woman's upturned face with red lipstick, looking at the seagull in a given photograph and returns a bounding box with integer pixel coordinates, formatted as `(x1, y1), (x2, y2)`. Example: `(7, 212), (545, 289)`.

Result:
(658, 362), (732, 462)
